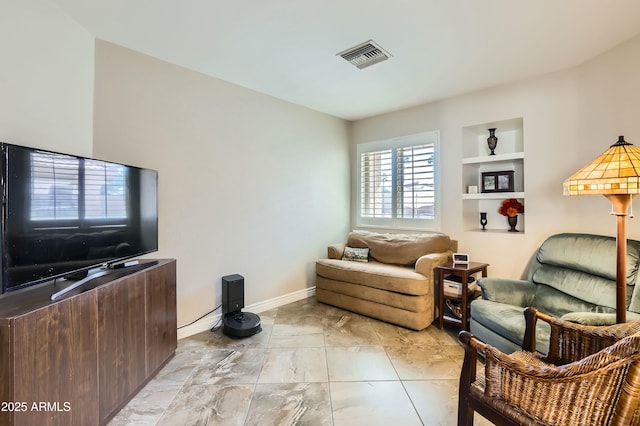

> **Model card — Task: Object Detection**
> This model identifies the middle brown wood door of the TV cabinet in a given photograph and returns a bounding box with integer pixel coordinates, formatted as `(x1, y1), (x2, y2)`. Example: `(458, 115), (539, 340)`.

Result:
(98, 272), (146, 422)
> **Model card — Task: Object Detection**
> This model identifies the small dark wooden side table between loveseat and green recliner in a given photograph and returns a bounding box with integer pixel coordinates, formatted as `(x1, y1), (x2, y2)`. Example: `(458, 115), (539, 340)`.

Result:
(436, 262), (489, 331)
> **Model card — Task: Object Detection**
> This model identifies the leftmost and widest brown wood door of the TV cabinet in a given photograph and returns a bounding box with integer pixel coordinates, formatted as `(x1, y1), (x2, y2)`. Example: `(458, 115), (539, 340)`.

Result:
(11, 291), (98, 426)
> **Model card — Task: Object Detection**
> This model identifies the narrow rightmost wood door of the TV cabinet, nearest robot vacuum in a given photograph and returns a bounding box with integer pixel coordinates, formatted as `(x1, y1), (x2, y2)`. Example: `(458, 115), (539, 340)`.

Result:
(146, 260), (178, 377)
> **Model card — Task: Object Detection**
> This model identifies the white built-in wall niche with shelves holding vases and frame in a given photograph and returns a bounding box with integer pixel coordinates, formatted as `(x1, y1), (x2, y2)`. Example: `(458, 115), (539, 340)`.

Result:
(461, 118), (526, 235)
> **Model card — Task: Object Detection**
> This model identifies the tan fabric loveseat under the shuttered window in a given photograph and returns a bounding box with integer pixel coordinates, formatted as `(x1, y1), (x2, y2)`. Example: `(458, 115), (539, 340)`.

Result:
(316, 231), (457, 330)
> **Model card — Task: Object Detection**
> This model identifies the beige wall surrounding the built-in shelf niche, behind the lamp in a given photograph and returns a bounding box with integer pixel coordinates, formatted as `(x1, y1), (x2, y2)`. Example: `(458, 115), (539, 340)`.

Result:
(351, 37), (640, 277)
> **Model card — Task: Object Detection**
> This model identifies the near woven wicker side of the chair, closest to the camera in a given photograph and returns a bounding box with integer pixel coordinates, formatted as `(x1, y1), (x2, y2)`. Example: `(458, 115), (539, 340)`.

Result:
(484, 336), (640, 424)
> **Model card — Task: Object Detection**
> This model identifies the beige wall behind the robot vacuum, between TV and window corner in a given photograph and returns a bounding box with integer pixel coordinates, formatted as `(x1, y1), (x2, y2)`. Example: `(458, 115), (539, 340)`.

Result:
(94, 41), (349, 332)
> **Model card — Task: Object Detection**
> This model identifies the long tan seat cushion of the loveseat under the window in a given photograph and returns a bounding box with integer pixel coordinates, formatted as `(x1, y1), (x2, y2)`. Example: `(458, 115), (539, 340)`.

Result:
(316, 259), (433, 295)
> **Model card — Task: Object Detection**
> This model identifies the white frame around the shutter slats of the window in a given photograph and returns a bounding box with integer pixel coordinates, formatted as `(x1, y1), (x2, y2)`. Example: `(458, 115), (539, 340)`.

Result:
(354, 130), (441, 231)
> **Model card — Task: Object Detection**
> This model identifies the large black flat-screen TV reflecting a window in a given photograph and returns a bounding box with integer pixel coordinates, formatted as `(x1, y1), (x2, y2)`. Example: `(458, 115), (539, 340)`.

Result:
(0, 143), (158, 292)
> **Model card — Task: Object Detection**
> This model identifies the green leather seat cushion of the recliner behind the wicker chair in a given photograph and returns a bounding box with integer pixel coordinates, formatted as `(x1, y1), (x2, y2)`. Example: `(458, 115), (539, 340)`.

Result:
(471, 299), (551, 353)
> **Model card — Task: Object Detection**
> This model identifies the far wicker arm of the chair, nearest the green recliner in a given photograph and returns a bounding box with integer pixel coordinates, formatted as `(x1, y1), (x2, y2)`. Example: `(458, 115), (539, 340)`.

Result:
(522, 307), (640, 365)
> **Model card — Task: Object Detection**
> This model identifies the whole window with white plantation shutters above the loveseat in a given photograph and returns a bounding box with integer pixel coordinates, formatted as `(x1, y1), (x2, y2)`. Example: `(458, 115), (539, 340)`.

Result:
(357, 132), (439, 228)
